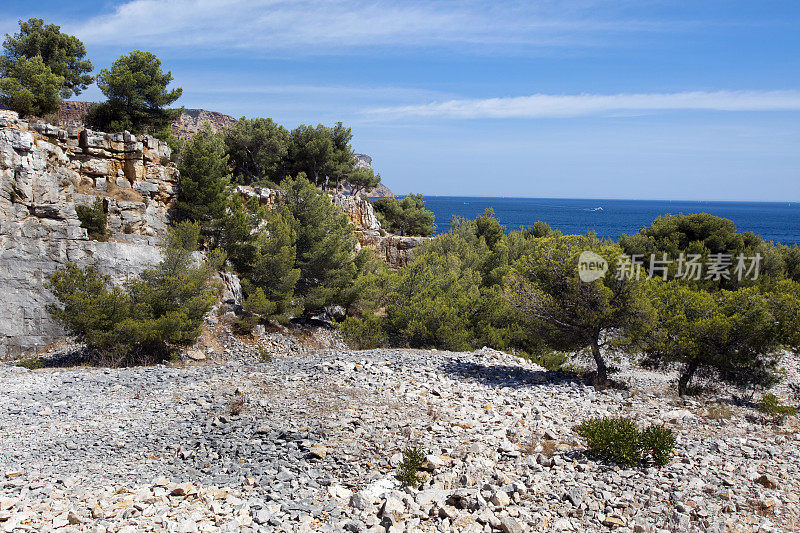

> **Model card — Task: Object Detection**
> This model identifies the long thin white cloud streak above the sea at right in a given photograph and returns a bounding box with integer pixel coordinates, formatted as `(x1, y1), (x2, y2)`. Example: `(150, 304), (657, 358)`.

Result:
(368, 91), (800, 119)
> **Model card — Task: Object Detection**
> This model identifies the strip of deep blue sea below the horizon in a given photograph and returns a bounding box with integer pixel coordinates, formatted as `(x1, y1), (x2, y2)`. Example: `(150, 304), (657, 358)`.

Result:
(418, 196), (800, 244)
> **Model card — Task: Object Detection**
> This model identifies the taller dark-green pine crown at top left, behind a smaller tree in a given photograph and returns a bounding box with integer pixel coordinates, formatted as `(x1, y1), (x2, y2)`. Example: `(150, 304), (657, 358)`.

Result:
(0, 18), (94, 98)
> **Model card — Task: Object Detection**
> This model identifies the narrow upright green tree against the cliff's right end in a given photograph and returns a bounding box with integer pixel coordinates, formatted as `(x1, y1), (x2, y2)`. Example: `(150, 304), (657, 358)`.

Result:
(176, 124), (231, 227)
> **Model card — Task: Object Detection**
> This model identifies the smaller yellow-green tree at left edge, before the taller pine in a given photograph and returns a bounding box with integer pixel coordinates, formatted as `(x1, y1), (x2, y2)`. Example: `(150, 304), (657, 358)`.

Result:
(0, 56), (64, 117)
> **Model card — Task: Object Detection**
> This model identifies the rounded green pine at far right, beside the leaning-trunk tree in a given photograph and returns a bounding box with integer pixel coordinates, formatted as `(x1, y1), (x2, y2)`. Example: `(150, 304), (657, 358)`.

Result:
(643, 281), (798, 395)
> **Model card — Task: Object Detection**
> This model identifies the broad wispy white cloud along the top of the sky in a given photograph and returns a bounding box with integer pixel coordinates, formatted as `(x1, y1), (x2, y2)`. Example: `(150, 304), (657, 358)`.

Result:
(61, 0), (676, 53)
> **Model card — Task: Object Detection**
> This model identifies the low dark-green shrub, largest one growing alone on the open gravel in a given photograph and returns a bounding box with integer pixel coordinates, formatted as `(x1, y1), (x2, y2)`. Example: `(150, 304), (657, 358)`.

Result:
(575, 418), (675, 466)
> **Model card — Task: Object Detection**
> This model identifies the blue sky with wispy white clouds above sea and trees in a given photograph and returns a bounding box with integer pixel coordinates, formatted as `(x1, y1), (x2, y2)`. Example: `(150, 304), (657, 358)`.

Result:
(0, 0), (800, 201)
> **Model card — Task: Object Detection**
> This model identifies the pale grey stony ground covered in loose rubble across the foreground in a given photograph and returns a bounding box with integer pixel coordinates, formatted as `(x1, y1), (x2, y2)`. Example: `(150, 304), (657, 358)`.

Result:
(0, 333), (800, 533)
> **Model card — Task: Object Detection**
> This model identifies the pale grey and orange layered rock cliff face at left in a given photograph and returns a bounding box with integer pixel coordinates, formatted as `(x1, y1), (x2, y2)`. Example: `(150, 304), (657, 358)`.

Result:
(0, 111), (178, 359)
